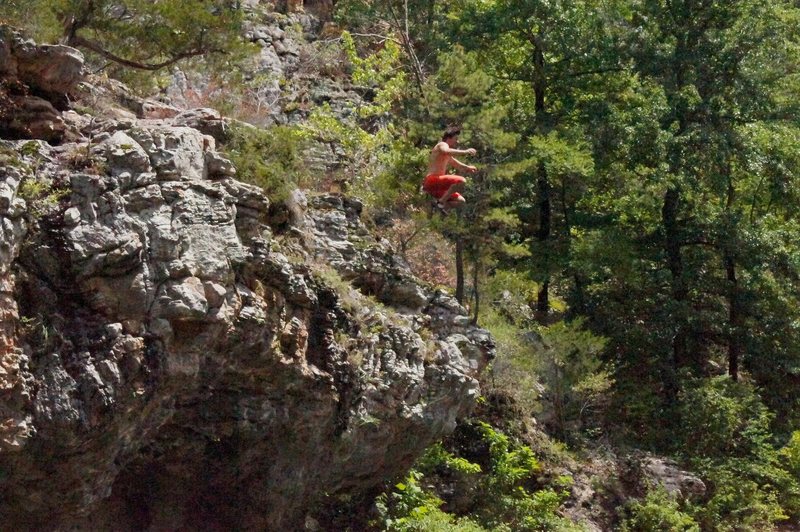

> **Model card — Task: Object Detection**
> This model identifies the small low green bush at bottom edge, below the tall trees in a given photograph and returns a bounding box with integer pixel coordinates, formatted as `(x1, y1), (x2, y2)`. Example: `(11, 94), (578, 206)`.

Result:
(620, 489), (700, 532)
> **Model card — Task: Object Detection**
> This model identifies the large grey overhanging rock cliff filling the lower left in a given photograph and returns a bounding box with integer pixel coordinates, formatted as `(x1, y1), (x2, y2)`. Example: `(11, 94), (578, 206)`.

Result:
(0, 102), (493, 530)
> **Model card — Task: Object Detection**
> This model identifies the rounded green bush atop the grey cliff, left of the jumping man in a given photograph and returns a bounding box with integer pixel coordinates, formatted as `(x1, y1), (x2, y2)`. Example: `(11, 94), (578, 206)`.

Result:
(222, 125), (310, 201)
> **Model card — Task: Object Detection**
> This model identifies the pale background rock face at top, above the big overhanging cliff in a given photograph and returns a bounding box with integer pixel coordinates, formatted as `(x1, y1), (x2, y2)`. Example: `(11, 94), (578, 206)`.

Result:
(169, 0), (366, 141)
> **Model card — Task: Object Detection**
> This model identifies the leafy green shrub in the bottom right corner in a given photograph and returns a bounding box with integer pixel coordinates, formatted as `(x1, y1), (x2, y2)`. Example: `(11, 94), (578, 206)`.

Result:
(681, 377), (800, 531)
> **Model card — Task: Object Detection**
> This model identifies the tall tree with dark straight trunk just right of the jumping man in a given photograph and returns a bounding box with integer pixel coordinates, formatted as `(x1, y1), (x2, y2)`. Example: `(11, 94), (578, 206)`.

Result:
(454, 0), (622, 316)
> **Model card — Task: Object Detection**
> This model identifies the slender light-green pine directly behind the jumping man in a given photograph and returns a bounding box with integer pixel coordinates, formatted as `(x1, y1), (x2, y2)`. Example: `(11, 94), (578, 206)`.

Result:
(383, 46), (519, 308)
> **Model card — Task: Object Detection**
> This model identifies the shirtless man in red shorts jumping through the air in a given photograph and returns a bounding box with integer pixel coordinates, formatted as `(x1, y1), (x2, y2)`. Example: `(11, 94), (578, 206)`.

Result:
(422, 127), (478, 212)
